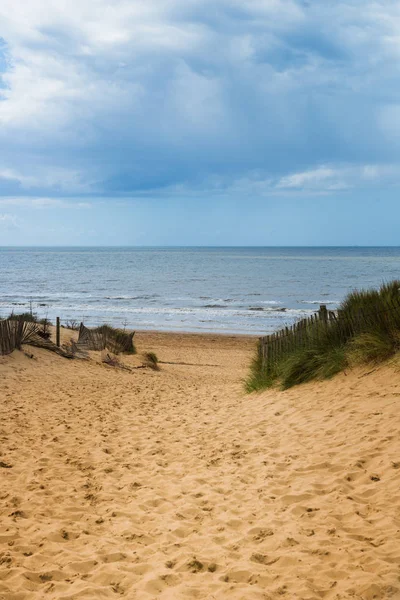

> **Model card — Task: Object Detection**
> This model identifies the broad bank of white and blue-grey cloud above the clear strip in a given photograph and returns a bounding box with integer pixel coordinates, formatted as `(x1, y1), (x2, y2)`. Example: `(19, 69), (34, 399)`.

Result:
(0, 0), (400, 197)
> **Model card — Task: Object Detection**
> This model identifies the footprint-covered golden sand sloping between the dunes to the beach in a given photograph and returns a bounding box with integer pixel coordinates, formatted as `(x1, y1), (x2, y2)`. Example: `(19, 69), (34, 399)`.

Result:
(0, 333), (400, 600)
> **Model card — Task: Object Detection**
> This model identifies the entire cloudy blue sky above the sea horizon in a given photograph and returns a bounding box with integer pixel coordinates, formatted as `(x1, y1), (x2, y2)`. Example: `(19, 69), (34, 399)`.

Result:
(0, 0), (400, 246)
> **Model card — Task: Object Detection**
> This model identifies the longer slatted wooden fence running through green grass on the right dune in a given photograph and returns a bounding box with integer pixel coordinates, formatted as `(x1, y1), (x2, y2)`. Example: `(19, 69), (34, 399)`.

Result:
(258, 299), (400, 370)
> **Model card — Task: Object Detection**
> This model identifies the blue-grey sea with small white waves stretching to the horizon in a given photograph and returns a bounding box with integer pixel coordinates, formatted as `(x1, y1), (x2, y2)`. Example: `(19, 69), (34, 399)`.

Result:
(0, 247), (400, 334)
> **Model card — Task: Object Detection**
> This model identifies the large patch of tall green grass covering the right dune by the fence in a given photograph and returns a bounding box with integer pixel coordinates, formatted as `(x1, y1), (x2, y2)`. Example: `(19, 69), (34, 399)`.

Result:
(245, 280), (400, 392)
